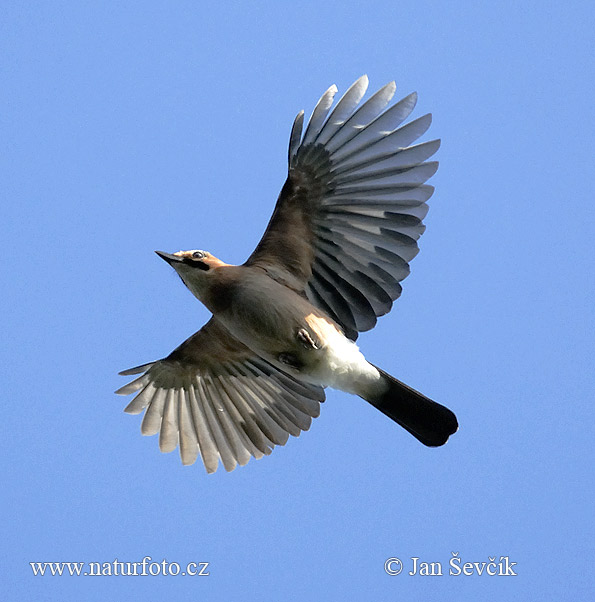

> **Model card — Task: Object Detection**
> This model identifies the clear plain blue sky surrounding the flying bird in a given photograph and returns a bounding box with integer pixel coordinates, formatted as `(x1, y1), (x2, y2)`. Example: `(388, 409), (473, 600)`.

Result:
(0, 0), (595, 601)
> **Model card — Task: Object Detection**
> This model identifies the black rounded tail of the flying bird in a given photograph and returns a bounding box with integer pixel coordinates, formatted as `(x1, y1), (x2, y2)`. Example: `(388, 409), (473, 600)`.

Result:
(364, 367), (459, 447)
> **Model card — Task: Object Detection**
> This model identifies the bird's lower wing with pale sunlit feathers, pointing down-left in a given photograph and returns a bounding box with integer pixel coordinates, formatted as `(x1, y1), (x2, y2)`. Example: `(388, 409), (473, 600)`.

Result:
(116, 318), (325, 472)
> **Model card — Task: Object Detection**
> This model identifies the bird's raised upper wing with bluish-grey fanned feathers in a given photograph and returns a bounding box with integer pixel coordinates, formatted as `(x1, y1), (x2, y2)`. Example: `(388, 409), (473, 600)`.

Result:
(246, 76), (440, 339)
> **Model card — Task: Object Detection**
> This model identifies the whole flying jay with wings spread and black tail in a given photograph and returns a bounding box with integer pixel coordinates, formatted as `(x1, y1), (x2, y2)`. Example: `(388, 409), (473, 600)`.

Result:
(116, 75), (458, 473)
